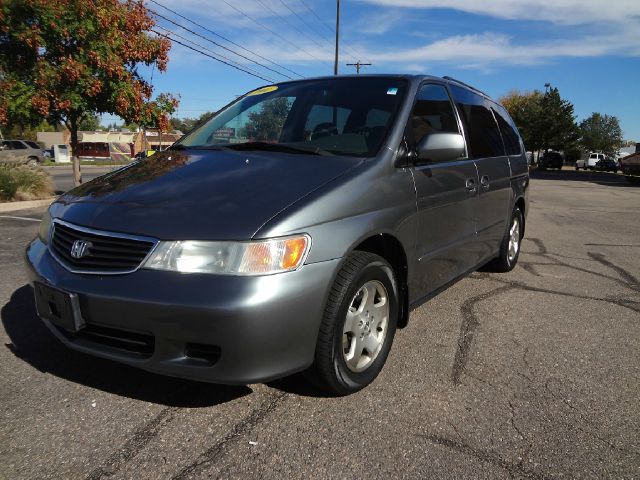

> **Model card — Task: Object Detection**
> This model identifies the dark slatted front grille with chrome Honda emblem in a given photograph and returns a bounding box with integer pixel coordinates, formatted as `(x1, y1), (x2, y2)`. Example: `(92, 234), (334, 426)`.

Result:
(50, 220), (156, 274)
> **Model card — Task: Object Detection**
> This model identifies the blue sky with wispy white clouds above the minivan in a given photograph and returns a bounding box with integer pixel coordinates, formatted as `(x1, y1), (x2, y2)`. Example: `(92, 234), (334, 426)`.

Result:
(103, 0), (640, 142)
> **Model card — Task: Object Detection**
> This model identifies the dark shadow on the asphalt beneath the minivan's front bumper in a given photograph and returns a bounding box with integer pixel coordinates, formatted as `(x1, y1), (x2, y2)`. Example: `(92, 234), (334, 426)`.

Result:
(0, 285), (252, 408)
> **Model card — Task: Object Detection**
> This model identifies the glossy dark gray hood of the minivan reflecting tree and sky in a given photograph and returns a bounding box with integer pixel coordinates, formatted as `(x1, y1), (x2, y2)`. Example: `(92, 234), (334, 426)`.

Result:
(51, 150), (361, 240)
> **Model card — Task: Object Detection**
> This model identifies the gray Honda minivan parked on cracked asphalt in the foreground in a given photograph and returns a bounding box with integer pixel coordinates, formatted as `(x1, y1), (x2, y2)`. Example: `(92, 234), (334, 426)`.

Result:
(26, 75), (529, 394)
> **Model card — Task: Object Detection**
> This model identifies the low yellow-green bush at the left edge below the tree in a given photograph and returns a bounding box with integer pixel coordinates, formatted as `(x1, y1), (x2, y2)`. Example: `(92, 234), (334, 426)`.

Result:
(0, 163), (53, 202)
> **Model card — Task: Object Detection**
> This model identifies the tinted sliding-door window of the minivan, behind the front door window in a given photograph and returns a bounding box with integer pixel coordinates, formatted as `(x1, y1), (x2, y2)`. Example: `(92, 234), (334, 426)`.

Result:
(451, 85), (505, 158)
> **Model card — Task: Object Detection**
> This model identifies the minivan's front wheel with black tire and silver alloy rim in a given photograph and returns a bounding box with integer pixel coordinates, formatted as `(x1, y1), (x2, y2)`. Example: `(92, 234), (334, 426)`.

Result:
(310, 251), (398, 395)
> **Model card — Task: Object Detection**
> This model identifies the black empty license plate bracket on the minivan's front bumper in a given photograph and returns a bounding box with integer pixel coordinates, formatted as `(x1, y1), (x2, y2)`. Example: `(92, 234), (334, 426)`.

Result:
(34, 282), (84, 332)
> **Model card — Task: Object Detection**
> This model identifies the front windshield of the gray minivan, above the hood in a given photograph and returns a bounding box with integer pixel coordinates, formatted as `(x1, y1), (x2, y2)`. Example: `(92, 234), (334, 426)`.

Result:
(172, 77), (407, 157)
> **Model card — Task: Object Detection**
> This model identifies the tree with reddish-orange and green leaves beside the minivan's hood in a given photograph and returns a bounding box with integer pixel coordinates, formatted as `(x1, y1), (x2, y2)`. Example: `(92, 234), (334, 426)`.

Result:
(0, 0), (177, 184)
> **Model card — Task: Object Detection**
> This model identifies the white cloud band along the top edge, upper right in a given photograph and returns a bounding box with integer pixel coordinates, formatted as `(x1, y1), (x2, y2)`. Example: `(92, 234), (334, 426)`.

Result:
(360, 0), (640, 25)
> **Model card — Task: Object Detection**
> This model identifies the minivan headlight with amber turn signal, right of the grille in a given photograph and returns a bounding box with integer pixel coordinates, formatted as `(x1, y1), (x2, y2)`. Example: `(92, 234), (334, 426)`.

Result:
(144, 235), (311, 275)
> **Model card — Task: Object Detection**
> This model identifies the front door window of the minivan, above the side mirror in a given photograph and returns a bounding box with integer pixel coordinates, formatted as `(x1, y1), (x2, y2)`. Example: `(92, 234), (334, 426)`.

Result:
(410, 84), (460, 145)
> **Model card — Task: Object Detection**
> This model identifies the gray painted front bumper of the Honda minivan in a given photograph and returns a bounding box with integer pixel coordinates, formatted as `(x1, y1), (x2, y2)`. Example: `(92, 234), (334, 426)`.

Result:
(25, 239), (340, 384)
